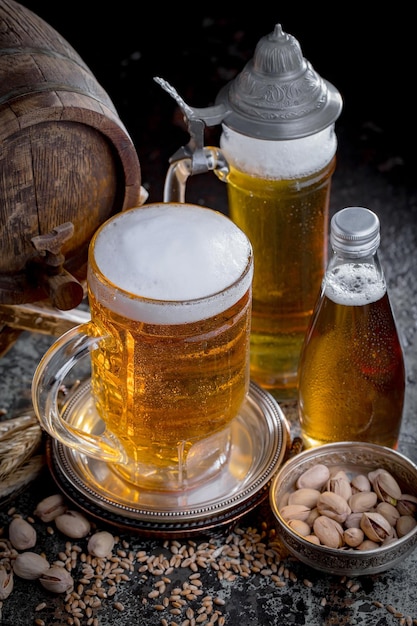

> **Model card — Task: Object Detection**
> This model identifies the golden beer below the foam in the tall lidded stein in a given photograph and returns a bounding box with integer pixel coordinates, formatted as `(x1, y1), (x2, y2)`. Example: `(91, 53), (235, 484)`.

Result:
(224, 160), (335, 398)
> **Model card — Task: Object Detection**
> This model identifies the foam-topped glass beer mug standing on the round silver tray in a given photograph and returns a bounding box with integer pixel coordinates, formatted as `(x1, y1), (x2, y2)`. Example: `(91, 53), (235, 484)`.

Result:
(32, 203), (253, 491)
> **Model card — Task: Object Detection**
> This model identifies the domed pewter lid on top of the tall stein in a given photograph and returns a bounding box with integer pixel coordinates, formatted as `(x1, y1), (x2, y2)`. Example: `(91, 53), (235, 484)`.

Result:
(216, 24), (342, 140)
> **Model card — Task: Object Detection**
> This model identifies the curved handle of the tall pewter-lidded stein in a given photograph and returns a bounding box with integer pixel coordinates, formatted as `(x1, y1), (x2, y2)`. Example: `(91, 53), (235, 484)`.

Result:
(164, 146), (229, 203)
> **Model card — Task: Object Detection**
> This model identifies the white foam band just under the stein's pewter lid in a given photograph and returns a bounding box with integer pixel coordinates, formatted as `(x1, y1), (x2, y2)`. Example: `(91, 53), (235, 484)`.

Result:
(220, 125), (337, 180)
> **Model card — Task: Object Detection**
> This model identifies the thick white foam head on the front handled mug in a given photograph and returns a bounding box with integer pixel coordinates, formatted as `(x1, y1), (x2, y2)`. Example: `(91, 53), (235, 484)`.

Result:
(88, 203), (252, 324)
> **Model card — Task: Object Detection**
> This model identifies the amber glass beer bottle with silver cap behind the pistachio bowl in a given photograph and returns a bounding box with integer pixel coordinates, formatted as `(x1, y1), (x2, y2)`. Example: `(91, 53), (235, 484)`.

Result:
(298, 207), (405, 448)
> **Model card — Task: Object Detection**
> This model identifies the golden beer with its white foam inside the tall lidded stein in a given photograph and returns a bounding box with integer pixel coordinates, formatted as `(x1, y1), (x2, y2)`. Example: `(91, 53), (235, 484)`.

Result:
(218, 127), (337, 400)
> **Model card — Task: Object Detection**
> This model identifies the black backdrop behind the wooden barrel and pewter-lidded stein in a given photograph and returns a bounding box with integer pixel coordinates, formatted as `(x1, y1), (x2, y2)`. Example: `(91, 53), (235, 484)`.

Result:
(15, 0), (417, 200)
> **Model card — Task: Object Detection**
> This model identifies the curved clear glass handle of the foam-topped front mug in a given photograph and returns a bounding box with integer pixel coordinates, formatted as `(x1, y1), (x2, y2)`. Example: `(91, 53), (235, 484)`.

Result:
(32, 323), (127, 463)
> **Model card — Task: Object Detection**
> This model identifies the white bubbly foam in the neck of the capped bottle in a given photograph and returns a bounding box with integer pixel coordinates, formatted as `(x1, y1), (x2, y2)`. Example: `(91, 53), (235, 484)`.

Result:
(325, 263), (387, 306)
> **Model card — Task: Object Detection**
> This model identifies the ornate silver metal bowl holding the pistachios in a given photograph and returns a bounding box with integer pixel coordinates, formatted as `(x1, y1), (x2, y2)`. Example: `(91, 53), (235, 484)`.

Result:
(270, 442), (417, 576)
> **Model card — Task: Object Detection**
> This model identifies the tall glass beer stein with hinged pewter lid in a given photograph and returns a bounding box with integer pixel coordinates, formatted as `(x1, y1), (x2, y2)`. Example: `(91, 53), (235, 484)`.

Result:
(155, 24), (342, 400)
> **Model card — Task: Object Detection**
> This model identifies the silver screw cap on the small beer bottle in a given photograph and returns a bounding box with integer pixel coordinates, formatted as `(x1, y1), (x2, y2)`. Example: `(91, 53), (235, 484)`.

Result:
(330, 207), (380, 257)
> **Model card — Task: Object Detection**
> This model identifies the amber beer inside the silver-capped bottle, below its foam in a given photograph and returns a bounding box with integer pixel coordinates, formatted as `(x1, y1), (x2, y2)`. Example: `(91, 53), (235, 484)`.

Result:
(299, 268), (405, 448)
